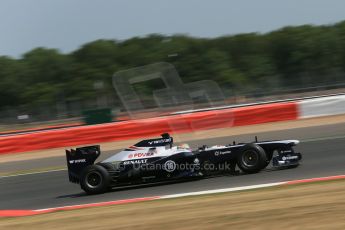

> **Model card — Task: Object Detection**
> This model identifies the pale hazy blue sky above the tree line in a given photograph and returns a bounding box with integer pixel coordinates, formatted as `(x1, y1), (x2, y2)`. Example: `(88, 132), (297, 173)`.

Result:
(0, 0), (345, 57)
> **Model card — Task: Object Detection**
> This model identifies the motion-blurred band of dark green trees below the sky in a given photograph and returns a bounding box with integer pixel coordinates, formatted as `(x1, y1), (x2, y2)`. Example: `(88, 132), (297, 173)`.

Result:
(0, 21), (345, 109)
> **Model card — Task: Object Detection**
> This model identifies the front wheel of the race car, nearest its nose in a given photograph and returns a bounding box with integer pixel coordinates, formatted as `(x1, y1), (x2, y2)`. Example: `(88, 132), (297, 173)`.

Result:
(237, 143), (267, 173)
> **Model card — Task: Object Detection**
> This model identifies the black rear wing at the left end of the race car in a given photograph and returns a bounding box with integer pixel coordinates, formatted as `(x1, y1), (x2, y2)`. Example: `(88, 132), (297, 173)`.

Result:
(66, 145), (101, 183)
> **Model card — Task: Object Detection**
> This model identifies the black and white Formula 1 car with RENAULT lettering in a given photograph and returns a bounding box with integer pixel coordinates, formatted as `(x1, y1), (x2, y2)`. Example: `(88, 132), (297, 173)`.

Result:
(66, 133), (302, 194)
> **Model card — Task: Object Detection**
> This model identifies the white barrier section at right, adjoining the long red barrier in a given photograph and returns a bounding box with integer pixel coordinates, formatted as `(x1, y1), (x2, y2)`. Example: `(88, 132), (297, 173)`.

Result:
(297, 95), (345, 119)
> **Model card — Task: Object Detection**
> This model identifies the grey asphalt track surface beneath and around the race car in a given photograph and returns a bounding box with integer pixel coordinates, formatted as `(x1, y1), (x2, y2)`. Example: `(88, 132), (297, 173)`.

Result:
(0, 123), (345, 210)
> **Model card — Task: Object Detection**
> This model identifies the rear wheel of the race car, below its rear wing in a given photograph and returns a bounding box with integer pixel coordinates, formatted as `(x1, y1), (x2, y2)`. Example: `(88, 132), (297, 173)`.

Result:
(80, 165), (110, 194)
